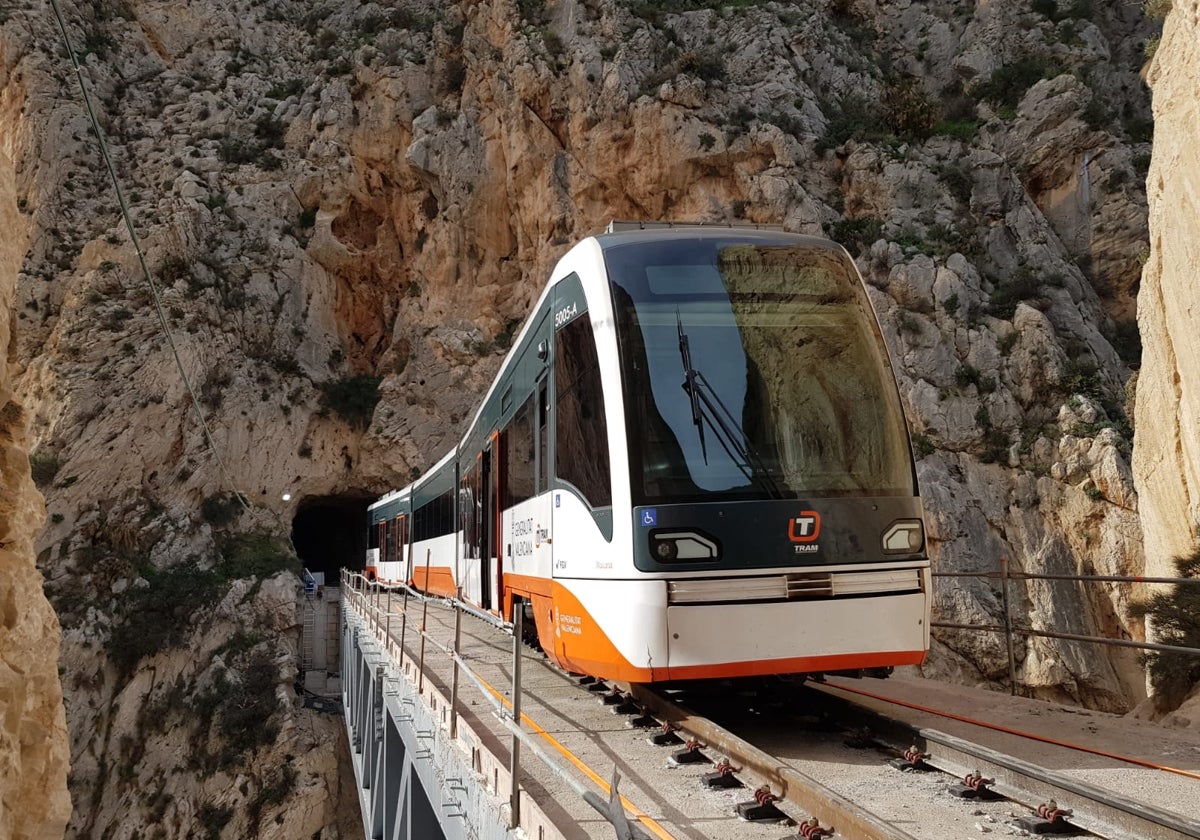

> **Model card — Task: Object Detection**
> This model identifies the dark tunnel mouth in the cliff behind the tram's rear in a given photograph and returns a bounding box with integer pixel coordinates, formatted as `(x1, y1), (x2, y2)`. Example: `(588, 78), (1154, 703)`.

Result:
(292, 496), (373, 587)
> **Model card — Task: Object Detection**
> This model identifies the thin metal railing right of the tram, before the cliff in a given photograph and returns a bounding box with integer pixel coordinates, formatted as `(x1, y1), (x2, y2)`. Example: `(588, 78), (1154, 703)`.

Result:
(930, 557), (1200, 695)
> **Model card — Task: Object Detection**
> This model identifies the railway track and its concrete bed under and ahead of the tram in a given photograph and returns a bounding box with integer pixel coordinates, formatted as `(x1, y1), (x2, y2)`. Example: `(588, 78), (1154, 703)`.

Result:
(360, 590), (1200, 840)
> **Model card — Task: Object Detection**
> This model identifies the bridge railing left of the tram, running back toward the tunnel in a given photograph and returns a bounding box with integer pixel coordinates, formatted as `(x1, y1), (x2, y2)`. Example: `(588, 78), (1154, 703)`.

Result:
(341, 569), (649, 840)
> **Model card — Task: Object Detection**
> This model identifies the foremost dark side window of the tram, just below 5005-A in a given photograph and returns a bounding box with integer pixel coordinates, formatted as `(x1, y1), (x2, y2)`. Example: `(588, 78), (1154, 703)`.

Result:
(554, 317), (612, 508)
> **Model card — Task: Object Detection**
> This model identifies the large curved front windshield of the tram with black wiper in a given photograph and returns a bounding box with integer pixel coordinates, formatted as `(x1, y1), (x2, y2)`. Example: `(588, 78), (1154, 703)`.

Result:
(605, 238), (913, 504)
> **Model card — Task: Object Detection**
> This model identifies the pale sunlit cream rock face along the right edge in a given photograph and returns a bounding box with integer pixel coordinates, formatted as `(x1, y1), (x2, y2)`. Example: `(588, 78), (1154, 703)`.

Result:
(1134, 0), (1200, 576)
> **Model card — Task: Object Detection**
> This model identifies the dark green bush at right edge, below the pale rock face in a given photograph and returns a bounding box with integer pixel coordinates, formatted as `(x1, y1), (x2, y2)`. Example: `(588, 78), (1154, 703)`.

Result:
(1129, 550), (1200, 710)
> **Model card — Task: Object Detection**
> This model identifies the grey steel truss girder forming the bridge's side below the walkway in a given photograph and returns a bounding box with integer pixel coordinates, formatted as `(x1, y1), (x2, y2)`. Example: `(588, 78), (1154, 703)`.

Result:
(342, 605), (514, 840)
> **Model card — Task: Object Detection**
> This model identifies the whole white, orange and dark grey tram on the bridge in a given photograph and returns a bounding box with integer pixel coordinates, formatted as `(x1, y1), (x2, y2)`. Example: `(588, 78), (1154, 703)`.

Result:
(367, 224), (930, 683)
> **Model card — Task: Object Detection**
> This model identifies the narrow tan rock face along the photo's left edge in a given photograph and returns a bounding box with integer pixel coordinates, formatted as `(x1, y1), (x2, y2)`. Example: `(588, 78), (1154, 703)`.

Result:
(0, 19), (71, 840)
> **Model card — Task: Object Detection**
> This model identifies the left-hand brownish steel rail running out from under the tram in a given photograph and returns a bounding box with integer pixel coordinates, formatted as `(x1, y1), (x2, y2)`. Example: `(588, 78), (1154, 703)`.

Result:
(626, 684), (917, 840)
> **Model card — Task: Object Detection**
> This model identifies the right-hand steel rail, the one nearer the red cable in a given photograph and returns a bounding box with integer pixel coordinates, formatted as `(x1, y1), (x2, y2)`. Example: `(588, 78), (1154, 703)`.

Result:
(809, 684), (1200, 840)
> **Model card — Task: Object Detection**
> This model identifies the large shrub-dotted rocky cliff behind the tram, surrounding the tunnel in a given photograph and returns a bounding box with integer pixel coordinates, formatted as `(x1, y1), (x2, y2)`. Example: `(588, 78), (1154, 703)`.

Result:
(0, 0), (1154, 838)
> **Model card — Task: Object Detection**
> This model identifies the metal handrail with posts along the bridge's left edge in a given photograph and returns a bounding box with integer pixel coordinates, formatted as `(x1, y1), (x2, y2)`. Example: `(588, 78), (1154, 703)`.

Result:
(342, 569), (648, 840)
